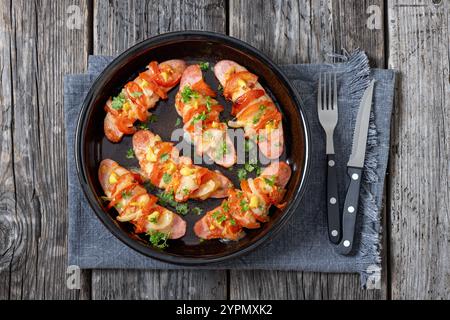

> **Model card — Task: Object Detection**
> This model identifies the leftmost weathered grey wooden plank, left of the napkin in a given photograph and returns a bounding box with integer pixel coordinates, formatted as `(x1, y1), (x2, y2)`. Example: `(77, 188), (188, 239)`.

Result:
(0, 0), (90, 299)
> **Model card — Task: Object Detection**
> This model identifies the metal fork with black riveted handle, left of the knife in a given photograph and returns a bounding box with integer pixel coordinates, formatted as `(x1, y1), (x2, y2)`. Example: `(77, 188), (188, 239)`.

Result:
(317, 73), (341, 244)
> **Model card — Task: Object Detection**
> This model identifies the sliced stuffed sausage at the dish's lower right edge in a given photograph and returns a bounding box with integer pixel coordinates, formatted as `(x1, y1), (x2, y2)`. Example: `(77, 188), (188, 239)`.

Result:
(194, 162), (291, 240)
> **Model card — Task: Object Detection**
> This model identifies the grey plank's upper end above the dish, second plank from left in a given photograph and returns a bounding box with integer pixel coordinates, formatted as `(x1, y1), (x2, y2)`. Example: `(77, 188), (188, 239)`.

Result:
(94, 0), (226, 55)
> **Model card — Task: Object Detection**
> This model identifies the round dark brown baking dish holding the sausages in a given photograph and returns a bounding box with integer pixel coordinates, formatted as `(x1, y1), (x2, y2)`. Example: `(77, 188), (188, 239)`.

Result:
(75, 31), (310, 265)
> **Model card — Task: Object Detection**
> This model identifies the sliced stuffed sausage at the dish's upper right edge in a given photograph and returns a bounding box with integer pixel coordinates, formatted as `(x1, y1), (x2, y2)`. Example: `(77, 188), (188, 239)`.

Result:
(214, 60), (284, 159)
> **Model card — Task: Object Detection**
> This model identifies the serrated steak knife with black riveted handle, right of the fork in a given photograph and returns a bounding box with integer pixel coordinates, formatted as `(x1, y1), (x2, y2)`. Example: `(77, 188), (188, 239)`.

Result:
(338, 80), (375, 255)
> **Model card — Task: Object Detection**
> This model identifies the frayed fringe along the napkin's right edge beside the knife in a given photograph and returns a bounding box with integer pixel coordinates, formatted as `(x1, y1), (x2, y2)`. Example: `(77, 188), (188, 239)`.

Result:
(342, 49), (382, 288)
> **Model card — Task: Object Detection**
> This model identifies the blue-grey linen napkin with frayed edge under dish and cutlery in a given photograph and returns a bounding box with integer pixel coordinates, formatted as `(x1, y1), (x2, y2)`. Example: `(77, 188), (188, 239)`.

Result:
(64, 51), (395, 285)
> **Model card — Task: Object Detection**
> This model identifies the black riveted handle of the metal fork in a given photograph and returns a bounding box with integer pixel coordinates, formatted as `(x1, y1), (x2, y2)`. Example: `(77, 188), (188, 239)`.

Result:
(327, 154), (341, 244)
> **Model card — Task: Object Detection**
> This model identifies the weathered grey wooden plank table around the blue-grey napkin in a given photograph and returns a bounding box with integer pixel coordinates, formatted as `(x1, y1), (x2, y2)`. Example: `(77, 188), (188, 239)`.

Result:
(0, 0), (450, 299)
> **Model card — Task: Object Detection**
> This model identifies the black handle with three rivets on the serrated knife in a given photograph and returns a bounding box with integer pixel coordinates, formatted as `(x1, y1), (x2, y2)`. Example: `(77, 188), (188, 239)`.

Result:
(339, 167), (362, 255)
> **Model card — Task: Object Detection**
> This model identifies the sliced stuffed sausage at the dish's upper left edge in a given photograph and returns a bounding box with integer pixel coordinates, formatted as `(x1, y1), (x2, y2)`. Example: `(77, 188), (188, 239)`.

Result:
(104, 60), (186, 142)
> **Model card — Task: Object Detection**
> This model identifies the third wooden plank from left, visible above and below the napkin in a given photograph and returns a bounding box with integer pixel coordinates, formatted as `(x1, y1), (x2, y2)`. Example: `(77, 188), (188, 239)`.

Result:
(229, 0), (386, 299)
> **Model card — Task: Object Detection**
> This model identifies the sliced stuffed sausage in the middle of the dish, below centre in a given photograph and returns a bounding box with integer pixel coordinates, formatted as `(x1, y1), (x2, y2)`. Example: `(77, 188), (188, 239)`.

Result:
(133, 130), (233, 202)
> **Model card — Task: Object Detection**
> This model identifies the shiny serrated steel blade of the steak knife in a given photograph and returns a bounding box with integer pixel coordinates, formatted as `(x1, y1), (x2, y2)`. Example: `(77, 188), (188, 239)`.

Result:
(347, 80), (375, 168)
